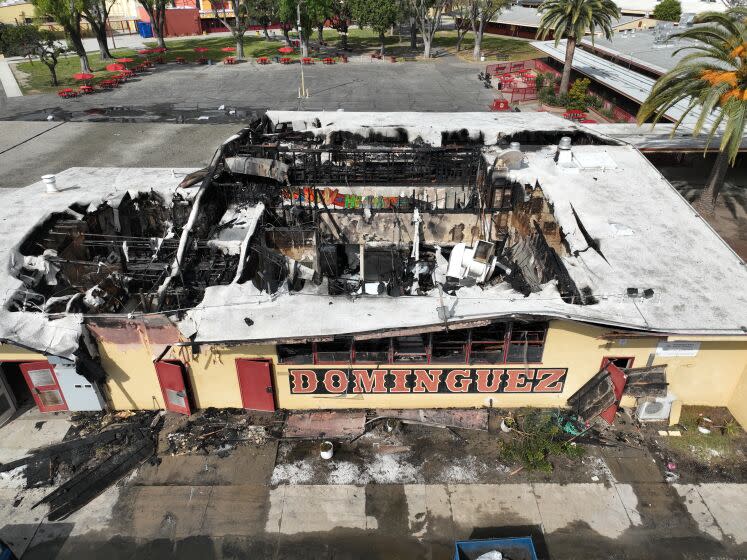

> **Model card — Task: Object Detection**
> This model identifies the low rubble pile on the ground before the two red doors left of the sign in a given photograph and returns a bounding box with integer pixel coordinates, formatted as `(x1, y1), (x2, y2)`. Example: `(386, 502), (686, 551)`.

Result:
(166, 408), (269, 457)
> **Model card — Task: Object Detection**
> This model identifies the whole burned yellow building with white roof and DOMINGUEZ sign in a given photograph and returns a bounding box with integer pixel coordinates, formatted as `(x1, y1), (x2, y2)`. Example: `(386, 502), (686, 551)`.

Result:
(0, 111), (747, 428)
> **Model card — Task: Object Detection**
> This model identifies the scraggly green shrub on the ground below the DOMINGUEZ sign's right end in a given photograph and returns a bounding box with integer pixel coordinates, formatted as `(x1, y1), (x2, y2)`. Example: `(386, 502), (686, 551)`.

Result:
(501, 411), (584, 472)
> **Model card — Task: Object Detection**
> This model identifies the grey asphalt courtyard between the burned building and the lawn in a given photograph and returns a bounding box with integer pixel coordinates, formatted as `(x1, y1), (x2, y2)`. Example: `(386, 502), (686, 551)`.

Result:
(0, 56), (495, 118)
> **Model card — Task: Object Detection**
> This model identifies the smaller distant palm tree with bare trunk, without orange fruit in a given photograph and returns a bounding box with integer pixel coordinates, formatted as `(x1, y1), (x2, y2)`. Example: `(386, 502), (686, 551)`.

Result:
(537, 0), (620, 93)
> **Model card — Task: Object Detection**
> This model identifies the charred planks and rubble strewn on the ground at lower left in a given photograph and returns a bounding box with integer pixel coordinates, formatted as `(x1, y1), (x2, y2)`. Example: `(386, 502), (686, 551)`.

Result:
(0, 408), (282, 521)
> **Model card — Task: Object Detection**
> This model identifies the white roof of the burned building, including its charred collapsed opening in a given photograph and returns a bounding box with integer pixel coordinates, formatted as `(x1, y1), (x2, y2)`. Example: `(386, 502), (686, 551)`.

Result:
(0, 111), (747, 357)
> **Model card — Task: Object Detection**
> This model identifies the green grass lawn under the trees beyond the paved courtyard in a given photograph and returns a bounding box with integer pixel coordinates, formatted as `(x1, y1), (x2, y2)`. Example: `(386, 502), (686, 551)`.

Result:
(11, 28), (539, 94)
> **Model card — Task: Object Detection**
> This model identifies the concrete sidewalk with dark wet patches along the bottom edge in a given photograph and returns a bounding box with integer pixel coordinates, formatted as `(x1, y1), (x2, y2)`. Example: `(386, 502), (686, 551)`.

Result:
(5, 477), (747, 560)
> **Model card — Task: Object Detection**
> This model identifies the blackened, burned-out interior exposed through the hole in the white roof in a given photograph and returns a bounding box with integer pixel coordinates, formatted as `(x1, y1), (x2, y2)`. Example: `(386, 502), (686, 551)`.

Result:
(9, 117), (595, 315)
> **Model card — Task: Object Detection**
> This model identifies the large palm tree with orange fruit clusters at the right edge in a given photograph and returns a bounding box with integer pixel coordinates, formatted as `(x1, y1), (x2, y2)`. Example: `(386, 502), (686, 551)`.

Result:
(638, 10), (747, 215)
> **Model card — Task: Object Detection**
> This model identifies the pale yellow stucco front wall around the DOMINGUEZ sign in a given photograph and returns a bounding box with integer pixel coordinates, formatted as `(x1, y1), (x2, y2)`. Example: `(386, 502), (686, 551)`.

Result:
(14, 321), (747, 418)
